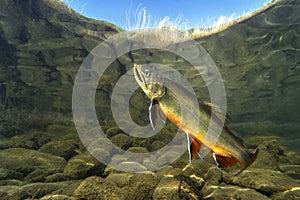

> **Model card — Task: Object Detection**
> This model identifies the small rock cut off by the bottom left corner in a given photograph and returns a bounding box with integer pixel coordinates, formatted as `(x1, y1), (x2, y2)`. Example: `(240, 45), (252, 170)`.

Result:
(0, 185), (29, 200)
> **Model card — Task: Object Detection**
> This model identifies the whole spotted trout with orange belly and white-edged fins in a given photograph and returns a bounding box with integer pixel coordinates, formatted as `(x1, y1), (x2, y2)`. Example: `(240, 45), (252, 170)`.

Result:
(133, 64), (258, 173)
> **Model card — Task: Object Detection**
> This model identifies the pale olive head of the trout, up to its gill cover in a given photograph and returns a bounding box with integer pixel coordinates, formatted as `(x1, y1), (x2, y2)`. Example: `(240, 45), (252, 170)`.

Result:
(133, 64), (166, 99)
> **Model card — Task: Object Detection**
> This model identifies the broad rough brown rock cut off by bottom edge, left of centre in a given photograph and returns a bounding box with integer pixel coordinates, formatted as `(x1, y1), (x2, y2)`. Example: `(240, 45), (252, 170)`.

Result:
(74, 173), (157, 200)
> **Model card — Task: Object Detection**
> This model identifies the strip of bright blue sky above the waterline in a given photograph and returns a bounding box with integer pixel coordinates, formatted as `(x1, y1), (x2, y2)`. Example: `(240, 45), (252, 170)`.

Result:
(64, 0), (270, 29)
